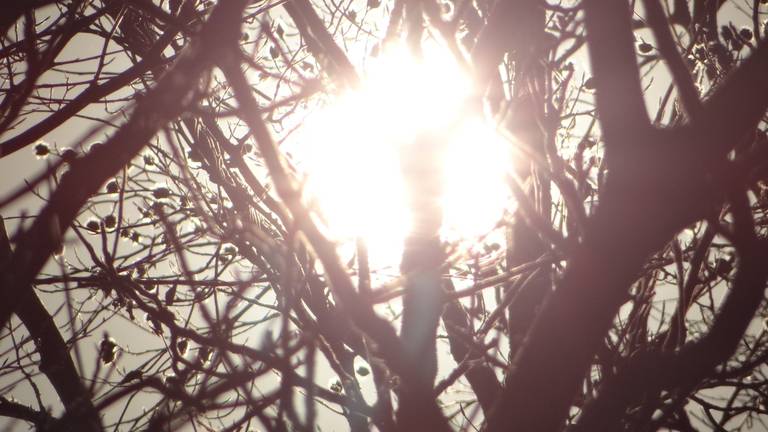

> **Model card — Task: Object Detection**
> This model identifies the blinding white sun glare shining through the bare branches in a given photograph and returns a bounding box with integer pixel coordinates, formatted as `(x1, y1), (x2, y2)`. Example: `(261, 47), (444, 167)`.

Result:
(288, 42), (511, 268)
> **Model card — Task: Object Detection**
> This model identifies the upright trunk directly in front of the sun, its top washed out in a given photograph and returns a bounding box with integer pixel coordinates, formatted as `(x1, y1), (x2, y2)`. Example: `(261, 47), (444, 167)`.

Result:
(397, 136), (447, 430)
